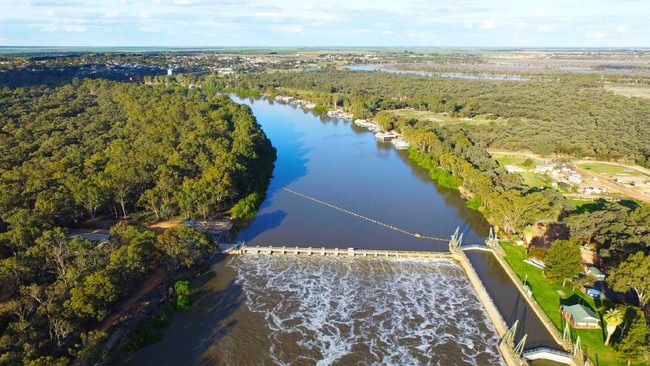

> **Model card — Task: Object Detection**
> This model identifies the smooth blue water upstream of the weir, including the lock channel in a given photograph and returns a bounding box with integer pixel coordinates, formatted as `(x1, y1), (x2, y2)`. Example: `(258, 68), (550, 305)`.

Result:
(230, 94), (553, 345)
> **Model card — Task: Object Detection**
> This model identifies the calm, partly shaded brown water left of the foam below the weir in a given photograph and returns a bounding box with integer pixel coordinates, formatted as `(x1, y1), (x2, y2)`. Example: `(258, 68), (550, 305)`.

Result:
(121, 255), (270, 366)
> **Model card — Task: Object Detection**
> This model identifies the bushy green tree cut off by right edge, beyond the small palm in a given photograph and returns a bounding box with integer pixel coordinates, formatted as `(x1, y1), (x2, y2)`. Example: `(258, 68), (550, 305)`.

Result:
(608, 252), (650, 308)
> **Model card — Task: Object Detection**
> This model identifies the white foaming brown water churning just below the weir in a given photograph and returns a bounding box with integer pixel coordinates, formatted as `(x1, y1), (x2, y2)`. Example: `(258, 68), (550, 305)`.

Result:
(231, 255), (503, 365)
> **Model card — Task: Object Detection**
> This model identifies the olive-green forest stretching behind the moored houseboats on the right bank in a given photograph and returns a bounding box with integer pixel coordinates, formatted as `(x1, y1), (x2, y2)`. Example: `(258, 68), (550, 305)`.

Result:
(224, 70), (650, 166)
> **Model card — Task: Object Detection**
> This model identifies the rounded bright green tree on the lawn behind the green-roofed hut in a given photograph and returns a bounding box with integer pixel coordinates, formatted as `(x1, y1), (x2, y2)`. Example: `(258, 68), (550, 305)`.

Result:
(544, 239), (582, 287)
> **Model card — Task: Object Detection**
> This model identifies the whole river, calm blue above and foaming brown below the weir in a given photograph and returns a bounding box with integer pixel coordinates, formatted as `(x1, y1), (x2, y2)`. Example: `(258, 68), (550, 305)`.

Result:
(125, 97), (553, 365)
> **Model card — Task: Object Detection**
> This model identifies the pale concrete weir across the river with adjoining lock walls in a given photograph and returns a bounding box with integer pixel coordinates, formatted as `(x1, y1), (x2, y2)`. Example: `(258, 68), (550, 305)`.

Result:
(222, 229), (584, 366)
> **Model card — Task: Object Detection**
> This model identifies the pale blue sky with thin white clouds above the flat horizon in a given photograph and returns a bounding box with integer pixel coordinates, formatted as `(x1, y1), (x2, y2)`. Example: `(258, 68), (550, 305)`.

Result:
(0, 0), (650, 48)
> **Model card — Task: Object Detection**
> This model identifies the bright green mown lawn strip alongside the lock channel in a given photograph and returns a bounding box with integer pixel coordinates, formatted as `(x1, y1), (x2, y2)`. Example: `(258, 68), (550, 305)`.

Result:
(501, 242), (642, 366)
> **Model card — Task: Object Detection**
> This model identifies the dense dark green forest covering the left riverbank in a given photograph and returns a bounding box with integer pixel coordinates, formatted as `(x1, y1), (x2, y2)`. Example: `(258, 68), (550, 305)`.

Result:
(0, 80), (275, 365)
